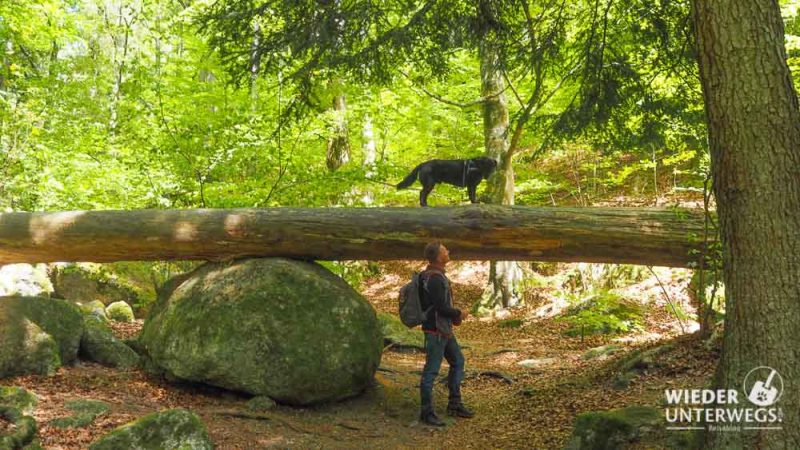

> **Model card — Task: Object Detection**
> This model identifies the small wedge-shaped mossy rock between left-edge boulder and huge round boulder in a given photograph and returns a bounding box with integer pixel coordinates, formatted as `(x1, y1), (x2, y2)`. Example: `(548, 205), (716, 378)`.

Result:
(80, 315), (139, 369)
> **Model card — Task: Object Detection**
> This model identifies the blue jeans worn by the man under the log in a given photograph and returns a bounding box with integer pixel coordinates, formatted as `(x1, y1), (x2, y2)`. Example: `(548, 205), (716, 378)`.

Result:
(419, 333), (464, 415)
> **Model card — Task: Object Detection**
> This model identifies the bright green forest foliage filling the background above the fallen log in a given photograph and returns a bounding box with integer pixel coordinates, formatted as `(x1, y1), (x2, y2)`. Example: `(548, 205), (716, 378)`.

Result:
(0, 0), (800, 216)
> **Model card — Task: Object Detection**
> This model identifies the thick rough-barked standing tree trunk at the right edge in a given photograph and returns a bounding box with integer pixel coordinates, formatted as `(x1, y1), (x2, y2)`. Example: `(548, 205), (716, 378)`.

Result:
(694, 0), (800, 449)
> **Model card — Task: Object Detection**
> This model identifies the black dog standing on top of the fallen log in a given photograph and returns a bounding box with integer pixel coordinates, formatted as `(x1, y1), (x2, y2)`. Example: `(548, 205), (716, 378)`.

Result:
(397, 156), (497, 206)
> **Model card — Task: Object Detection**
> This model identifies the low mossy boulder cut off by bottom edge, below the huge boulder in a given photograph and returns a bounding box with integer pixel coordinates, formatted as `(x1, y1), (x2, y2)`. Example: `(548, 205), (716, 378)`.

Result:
(89, 409), (214, 450)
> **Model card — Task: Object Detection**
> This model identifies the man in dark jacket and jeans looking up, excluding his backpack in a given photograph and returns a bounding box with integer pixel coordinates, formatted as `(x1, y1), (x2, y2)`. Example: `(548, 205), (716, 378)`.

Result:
(420, 242), (474, 427)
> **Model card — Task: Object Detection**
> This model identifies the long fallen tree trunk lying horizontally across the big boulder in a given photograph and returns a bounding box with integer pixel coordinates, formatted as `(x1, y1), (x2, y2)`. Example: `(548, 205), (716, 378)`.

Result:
(0, 205), (703, 267)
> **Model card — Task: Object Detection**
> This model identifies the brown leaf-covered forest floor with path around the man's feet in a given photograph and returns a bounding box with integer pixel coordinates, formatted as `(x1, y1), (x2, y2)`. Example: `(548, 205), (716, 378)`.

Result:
(6, 262), (717, 449)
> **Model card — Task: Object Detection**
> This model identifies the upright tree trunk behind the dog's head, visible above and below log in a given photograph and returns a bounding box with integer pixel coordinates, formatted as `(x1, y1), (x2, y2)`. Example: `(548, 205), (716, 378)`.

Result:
(478, 35), (522, 310)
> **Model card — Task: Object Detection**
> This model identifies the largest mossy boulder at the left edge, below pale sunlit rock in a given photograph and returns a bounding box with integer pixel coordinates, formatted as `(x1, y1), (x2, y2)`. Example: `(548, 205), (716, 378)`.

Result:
(0, 297), (83, 378)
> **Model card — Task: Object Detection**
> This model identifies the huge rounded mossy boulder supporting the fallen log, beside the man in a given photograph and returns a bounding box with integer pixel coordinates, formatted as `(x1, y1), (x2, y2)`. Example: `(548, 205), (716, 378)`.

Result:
(140, 258), (382, 405)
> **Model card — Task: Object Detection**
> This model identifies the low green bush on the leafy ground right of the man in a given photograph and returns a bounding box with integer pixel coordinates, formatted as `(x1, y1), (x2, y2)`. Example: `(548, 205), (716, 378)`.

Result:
(560, 291), (644, 337)
